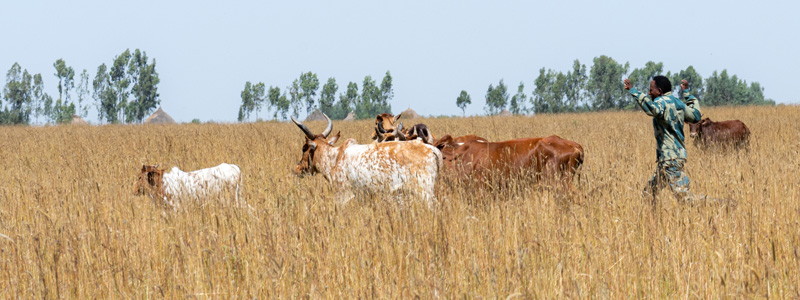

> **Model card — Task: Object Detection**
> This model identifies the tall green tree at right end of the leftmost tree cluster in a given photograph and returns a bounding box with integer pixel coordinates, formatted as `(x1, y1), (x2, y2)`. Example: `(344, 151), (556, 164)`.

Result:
(125, 49), (161, 123)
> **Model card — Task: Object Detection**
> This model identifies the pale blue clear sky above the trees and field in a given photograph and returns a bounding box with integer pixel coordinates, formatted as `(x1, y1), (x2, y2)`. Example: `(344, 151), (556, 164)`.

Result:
(0, 0), (800, 123)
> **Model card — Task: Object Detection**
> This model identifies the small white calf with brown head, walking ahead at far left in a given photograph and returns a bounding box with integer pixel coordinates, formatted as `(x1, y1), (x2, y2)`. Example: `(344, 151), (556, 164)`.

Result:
(134, 163), (242, 208)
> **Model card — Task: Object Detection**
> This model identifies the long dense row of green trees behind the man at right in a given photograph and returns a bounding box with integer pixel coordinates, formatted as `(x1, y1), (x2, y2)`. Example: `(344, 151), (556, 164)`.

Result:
(476, 55), (775, 115)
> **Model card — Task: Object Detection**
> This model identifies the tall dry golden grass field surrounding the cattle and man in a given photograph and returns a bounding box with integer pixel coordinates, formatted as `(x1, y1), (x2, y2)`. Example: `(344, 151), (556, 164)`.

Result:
(0, 106), (800, 299)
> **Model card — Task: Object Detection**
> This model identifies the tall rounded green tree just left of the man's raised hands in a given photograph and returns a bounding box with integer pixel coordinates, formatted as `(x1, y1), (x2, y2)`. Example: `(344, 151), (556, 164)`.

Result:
(586, 55), (631, 110)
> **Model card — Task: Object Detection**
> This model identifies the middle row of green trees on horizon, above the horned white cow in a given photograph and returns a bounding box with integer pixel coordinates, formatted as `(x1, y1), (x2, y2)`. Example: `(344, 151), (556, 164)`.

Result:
(238, 71), (394, 122)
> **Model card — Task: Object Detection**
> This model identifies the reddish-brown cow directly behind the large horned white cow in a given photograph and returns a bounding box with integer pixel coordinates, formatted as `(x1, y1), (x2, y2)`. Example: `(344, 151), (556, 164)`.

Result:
(434, 135), (583, 184)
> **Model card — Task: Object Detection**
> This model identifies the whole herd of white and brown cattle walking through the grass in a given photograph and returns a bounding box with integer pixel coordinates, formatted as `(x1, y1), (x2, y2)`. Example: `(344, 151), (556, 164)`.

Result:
(134, 113), (750, 208)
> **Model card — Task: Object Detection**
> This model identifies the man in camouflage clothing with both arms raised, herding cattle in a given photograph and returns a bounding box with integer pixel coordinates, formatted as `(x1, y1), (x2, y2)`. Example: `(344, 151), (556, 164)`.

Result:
(623, 75), (700, 204)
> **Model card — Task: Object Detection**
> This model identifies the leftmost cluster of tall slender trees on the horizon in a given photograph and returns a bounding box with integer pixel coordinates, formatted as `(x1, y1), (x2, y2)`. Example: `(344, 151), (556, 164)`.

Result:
(0, 49), (161, 124)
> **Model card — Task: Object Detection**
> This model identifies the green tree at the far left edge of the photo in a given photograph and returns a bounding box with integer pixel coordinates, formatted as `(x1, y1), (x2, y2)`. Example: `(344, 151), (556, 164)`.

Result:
(3, 63), (33, 124)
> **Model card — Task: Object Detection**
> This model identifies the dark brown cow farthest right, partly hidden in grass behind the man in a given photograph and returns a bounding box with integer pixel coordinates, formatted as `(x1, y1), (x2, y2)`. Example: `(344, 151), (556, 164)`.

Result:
(689, 118), (750, 148)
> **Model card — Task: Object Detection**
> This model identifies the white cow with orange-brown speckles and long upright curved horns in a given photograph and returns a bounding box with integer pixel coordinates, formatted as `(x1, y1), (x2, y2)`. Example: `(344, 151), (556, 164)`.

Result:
(292, 112), (442, 206)
